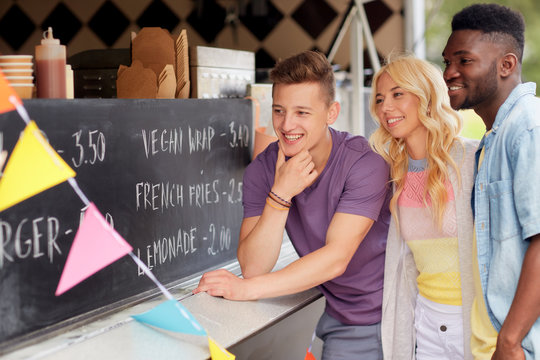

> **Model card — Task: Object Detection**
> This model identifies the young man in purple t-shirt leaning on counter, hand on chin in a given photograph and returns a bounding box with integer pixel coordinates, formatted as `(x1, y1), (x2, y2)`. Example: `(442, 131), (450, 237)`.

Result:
(195, 51), (391, 360)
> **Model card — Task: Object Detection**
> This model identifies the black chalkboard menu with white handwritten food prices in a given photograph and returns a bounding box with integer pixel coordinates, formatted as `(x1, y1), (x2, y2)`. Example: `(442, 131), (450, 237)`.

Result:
(0, 99), (252, 354)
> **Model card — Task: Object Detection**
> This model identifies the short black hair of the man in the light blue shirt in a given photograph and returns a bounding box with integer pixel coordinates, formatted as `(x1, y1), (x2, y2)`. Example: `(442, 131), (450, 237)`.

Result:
(452, 4), (525, 62)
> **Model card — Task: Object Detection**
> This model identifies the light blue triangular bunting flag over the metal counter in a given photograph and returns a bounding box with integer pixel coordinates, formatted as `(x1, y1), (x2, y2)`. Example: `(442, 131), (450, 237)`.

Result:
(131, 299), (206, 336)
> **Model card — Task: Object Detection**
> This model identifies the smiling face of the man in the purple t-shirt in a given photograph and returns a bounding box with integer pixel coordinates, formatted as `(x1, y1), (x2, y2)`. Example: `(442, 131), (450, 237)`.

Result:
(272, 82), (339, 159)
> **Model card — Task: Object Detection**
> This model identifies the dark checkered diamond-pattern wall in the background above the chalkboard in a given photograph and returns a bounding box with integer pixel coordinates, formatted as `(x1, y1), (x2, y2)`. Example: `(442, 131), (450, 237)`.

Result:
(0, 0), (404, 68)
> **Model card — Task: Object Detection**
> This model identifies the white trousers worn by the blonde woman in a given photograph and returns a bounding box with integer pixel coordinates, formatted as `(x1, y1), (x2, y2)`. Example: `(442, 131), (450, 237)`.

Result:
(414, 295), (463, 360)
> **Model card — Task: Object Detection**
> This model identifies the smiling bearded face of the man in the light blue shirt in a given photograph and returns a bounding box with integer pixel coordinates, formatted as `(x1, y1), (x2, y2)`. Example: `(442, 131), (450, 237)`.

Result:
(443, 30), (502, 112)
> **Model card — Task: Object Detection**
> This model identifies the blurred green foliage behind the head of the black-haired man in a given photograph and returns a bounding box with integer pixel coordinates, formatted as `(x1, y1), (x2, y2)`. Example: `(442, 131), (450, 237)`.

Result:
(425, 0), (540, 85)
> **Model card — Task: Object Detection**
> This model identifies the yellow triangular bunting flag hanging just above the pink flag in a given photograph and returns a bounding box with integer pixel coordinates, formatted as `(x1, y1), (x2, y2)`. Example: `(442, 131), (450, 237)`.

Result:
(0, 121), (75, 211)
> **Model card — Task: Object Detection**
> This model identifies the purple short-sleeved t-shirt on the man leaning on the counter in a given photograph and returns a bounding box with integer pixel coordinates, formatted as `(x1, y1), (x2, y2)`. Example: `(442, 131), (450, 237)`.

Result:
(243, 128), (391, 325)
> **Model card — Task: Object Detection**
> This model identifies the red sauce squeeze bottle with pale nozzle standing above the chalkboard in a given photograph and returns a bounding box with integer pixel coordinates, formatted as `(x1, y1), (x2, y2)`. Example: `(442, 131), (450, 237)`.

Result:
(36, 27), (66, 99)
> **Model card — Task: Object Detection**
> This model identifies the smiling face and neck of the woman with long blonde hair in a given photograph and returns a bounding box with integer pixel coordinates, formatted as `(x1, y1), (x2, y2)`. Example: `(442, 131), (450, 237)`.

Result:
(375, 72), (427, 159)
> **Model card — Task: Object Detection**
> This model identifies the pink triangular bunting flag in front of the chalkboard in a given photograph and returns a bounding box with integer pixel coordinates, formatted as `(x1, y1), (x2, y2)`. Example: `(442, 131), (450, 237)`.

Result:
(55, 203), (133, 296)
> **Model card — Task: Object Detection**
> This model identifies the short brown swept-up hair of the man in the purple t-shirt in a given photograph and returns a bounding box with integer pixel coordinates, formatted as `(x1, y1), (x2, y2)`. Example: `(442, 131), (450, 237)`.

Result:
(270, 50), (336, 105)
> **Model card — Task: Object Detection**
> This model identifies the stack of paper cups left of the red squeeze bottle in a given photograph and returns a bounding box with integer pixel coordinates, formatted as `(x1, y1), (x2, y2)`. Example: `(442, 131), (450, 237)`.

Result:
(0, 55), (34, 99)
